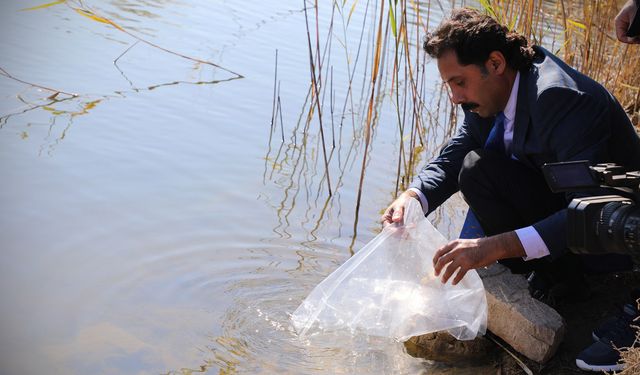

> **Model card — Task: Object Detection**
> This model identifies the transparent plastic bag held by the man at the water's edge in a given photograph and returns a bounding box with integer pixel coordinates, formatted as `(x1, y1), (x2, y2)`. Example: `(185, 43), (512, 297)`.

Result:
(291, 199), (487, 341)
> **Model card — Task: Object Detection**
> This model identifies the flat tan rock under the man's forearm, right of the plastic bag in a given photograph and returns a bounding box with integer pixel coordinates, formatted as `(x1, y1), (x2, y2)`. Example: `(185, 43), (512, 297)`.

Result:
(478, 264), (565, 363)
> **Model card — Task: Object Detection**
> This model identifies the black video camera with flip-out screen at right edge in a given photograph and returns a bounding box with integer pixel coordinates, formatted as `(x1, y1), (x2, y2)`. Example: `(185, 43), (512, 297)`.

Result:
(542, 161), (640, 261)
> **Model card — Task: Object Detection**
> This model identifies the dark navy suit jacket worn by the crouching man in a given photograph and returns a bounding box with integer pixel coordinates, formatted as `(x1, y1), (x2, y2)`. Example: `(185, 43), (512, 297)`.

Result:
(410, 47), (640, 257)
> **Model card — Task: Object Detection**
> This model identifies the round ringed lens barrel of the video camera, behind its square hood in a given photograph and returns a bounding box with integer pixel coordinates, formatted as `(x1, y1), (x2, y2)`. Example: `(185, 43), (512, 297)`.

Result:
(597, 201), (640, 253)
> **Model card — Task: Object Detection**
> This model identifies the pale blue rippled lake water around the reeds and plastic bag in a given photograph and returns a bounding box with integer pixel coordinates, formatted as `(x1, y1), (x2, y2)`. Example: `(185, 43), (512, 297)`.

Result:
(0, 0), (482, 374)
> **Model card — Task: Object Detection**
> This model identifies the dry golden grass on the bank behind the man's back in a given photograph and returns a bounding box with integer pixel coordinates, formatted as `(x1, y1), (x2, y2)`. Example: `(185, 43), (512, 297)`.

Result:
(481, 0), (640, 127)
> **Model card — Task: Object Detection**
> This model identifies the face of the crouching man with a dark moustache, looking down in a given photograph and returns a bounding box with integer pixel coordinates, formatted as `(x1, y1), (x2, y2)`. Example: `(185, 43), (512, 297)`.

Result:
(438, 50), (511, 117)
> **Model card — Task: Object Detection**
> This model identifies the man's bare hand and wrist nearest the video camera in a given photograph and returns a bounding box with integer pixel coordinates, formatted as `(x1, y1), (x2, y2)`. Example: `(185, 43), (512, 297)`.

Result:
(433, 232), (526, 285)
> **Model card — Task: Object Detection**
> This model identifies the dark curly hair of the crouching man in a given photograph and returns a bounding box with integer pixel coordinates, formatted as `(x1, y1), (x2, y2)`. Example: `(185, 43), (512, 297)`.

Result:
(424, 8), (535, 71)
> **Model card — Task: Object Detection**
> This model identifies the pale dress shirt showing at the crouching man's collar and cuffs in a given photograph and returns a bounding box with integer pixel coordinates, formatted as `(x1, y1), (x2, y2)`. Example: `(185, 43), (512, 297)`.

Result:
(409, 72), (549, 260)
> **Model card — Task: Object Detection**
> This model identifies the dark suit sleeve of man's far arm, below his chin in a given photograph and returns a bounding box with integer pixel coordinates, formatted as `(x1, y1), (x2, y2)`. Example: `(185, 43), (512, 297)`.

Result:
(409, 119), (480, 213)
